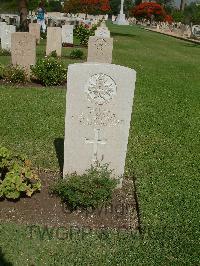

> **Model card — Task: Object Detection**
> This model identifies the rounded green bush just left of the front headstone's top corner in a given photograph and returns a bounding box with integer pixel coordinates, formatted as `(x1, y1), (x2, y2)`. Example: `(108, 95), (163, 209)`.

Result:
(31, 57), (67, 86)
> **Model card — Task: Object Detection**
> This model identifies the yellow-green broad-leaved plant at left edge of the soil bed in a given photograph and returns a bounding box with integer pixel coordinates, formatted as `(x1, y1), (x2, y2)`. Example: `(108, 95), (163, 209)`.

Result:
(0, 146), (41, 199)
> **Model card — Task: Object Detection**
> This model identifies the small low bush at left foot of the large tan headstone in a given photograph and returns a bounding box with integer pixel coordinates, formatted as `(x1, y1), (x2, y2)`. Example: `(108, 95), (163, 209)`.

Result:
(3, 66), (27, 83)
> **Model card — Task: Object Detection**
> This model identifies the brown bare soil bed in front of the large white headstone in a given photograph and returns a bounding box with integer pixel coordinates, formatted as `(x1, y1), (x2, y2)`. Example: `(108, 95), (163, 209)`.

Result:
(0, 172), (139, 230)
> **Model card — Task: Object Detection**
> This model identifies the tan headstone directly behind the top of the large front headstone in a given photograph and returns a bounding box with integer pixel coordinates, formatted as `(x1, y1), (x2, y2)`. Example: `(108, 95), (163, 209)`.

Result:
(87, 36), (113, 64)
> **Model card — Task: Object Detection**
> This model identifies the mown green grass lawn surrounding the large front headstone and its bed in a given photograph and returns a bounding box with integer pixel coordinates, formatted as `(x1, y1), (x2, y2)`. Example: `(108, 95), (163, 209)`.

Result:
(0, 25), (200, 265)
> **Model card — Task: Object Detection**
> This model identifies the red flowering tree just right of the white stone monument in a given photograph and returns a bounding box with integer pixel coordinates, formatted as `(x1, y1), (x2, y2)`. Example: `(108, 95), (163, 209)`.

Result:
(130, 2), (172, 22)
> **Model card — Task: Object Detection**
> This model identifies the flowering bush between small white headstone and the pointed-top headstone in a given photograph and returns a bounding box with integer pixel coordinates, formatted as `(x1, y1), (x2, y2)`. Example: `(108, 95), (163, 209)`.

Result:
(74, 24), (97, 46)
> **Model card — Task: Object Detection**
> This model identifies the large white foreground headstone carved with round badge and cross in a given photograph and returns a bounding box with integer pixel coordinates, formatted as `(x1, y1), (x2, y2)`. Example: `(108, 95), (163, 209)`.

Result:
(63, 63), (136, 185)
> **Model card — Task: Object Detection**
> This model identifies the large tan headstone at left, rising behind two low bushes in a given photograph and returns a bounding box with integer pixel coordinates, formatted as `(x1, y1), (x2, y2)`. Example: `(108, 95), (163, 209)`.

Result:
(11, 32), (36, 76)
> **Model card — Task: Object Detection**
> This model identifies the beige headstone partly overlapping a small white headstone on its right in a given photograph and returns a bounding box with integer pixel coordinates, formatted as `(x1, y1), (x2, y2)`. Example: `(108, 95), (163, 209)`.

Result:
(46, 27), (62, 56)
